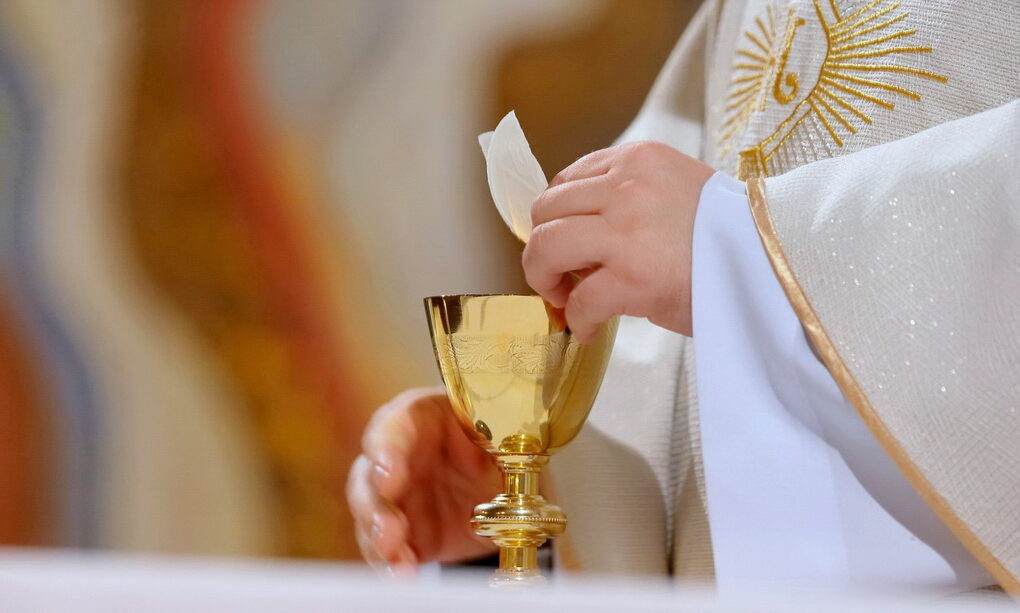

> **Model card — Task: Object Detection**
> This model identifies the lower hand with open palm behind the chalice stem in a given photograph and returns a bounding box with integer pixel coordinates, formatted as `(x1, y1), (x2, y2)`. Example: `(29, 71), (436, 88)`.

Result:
(347, 388), (501, 572)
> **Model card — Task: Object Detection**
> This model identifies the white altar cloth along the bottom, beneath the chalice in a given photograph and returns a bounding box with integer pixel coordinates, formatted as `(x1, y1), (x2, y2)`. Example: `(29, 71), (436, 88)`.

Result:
(0, 548), (1016, 613)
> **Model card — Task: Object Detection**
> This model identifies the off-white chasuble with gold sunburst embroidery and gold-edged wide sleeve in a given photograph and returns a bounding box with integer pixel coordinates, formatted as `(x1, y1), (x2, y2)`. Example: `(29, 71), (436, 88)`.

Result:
(551, 0), (1020, 593)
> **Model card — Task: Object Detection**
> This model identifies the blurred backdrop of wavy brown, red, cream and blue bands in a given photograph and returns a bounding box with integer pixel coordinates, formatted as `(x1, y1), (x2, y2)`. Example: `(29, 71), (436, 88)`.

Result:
(0, 0), (697, 559)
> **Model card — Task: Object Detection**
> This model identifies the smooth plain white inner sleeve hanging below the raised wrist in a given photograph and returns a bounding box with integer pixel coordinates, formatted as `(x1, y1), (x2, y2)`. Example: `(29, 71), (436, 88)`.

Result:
(692, 173), (995, 594)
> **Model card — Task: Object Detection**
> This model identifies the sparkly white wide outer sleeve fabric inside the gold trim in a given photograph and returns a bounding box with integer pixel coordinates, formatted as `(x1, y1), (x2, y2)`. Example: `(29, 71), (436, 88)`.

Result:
(766, 101), (1020, 587)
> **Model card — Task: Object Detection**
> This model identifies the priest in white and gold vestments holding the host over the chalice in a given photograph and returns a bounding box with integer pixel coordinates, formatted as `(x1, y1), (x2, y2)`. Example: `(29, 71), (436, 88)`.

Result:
(349, 0), (1020, 596)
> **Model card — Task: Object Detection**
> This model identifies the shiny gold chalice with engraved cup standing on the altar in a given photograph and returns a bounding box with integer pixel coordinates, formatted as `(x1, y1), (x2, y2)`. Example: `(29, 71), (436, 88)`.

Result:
(425, 295), (617, 585)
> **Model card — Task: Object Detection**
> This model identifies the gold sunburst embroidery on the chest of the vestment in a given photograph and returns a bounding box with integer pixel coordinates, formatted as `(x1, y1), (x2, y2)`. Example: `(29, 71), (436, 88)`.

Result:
(718, 0), (948, 178)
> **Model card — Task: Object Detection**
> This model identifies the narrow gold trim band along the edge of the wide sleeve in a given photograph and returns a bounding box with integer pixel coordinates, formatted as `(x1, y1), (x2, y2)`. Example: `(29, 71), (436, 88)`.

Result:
(747, 178), (1020, 600)
